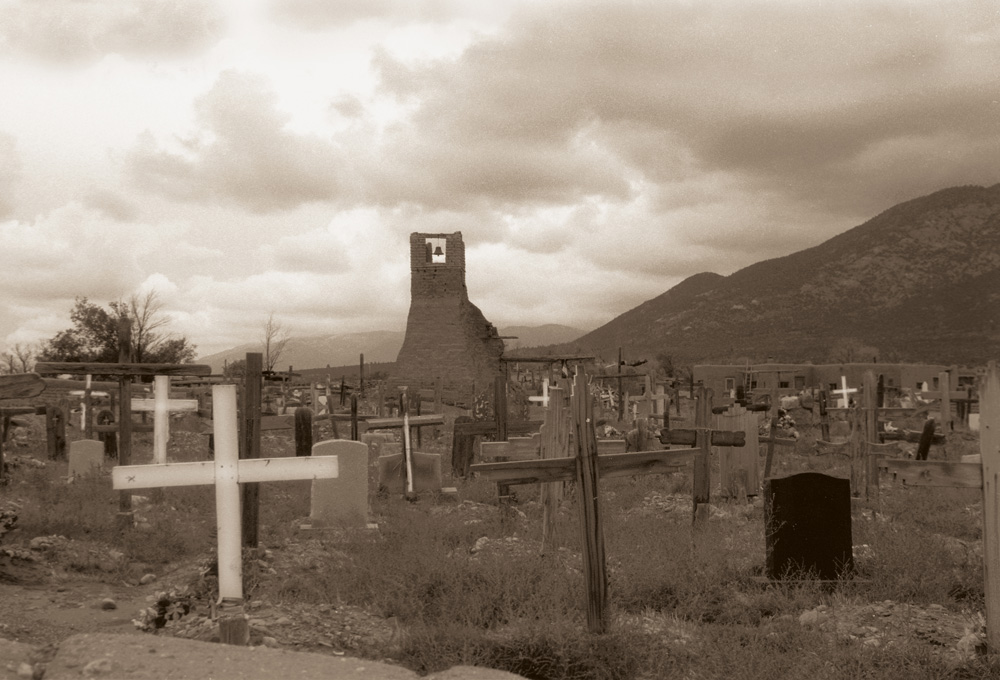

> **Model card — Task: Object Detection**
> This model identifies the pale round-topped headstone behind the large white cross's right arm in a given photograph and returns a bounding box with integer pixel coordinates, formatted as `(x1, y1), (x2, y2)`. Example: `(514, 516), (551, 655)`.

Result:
(309, 439), (368, 527)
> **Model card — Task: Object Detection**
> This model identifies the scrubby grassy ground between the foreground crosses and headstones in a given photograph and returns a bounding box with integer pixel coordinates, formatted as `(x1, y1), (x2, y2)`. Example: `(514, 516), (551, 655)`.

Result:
(0, 404), (1000, 680)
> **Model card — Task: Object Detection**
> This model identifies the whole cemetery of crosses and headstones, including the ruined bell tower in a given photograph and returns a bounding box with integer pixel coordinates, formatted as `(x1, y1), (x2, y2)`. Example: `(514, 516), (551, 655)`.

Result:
(0, 234), (1000, 679)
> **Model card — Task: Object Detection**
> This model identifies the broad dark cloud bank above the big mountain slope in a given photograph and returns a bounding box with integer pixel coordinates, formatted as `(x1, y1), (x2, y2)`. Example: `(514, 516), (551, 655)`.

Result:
(373, 2), (1000, 217)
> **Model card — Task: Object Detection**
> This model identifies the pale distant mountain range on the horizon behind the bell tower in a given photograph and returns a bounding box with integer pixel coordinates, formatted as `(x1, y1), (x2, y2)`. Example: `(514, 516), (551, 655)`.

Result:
(198, 324), (583, 373)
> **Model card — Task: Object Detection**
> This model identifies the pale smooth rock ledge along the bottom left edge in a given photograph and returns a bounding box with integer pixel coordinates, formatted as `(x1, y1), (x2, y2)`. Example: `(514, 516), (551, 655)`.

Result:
(0, 633), (521, 680)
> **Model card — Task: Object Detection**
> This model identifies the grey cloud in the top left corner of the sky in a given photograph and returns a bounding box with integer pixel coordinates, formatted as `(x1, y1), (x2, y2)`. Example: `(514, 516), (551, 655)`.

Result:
(0, 0), (223, 63)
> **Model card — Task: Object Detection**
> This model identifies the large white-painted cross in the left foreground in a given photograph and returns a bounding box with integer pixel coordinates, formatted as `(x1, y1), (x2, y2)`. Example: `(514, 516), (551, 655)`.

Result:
(111, 385), (338, 602)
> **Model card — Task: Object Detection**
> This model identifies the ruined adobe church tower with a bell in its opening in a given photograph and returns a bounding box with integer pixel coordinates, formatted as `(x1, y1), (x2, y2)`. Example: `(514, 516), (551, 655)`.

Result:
(392, 231), (504, 402)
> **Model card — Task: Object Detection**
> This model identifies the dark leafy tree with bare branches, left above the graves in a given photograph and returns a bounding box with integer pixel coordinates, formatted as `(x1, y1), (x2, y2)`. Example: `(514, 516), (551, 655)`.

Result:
(38, 291), (195, 364)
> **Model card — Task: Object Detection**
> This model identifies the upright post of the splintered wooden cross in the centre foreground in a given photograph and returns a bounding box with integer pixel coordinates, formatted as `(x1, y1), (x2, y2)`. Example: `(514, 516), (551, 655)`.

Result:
(573, 371), (608, 633)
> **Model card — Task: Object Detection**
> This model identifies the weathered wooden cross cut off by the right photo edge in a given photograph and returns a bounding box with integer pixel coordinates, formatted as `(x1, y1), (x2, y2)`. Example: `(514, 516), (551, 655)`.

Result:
(883, 361), (1000, 654)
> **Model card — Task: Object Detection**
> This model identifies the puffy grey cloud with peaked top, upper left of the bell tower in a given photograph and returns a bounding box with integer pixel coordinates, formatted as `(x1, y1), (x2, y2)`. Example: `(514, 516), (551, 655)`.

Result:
(127, 71), (344, 213)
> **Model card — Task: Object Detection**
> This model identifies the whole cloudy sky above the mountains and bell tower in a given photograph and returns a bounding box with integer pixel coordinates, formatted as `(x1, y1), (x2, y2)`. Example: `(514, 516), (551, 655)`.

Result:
(0, 0), (1000, 356)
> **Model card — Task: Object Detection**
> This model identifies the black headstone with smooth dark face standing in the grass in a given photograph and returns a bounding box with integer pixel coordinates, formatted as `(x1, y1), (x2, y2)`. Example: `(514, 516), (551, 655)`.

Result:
(764, 472), (854, 581)
